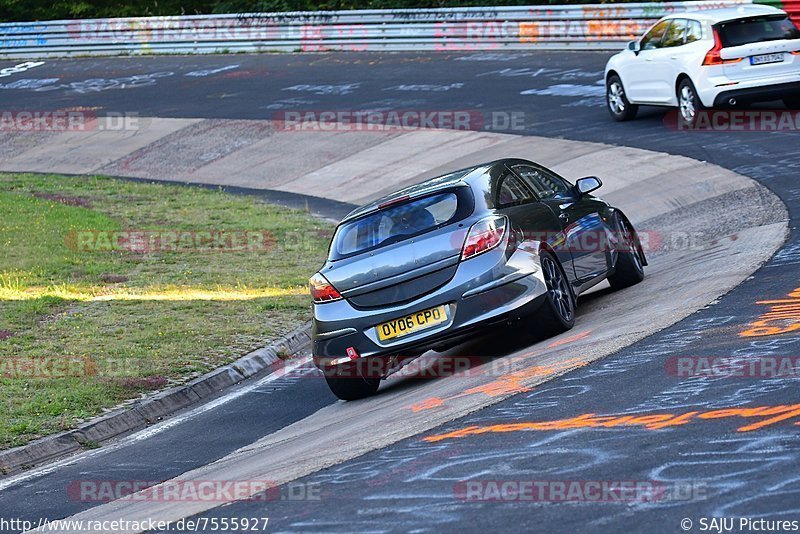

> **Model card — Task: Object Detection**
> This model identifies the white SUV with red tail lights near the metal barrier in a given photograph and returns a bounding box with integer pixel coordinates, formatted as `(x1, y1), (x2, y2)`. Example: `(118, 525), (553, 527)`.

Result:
(606, 5), (800, 124)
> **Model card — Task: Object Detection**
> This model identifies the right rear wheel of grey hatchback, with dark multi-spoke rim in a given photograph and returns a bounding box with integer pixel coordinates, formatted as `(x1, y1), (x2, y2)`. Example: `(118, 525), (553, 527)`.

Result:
(533, 251), (575, 337)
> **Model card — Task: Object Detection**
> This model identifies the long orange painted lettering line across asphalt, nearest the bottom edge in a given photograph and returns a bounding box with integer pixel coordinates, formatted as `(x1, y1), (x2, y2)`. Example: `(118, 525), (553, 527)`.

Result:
(423, 404), (800, 443)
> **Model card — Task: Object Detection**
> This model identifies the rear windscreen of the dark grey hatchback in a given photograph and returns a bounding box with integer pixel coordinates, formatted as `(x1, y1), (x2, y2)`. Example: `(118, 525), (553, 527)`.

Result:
(331, 191), (463, 260)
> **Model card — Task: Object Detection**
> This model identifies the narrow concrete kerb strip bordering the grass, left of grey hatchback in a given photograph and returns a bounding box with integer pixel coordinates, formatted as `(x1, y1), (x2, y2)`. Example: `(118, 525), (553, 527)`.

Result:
(0, 323), (311, 476)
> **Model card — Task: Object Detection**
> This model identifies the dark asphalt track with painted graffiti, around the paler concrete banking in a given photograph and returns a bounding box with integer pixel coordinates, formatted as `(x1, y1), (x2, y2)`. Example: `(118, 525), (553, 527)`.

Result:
(0, 52), (800, 532)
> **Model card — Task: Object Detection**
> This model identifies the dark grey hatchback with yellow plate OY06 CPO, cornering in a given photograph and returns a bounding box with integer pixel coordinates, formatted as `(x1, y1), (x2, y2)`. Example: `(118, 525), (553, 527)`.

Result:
(310, 159), (647, 400)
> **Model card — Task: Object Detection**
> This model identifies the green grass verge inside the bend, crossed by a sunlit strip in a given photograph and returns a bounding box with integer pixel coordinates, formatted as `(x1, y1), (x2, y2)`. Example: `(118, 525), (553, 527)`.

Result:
(0, 174), (332, 448)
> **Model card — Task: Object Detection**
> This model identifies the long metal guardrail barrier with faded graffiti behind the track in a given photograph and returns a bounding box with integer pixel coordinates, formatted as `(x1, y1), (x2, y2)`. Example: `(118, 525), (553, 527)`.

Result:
(0, 0), (800, 59)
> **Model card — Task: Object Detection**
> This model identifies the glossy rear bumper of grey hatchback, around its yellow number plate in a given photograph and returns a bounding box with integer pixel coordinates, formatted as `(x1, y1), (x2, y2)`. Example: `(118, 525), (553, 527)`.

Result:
(312, 245), (546, 369)
